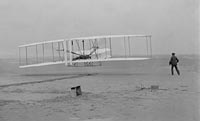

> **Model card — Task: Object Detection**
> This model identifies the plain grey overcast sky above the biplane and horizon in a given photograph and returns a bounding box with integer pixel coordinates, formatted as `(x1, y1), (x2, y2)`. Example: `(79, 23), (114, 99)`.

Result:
(0, 0), (199, 57)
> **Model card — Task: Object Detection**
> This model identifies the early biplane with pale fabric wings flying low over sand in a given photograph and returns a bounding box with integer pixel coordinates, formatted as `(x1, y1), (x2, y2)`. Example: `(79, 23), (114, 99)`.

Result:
(18, 35), (152, 68)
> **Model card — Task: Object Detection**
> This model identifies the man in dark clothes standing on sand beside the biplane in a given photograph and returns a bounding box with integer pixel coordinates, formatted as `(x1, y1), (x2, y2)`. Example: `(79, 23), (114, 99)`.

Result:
(169, 53), (180, 75)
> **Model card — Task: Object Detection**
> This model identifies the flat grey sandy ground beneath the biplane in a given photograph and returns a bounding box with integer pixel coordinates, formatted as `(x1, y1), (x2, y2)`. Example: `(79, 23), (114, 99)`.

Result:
(0, 58), (200, 121)
